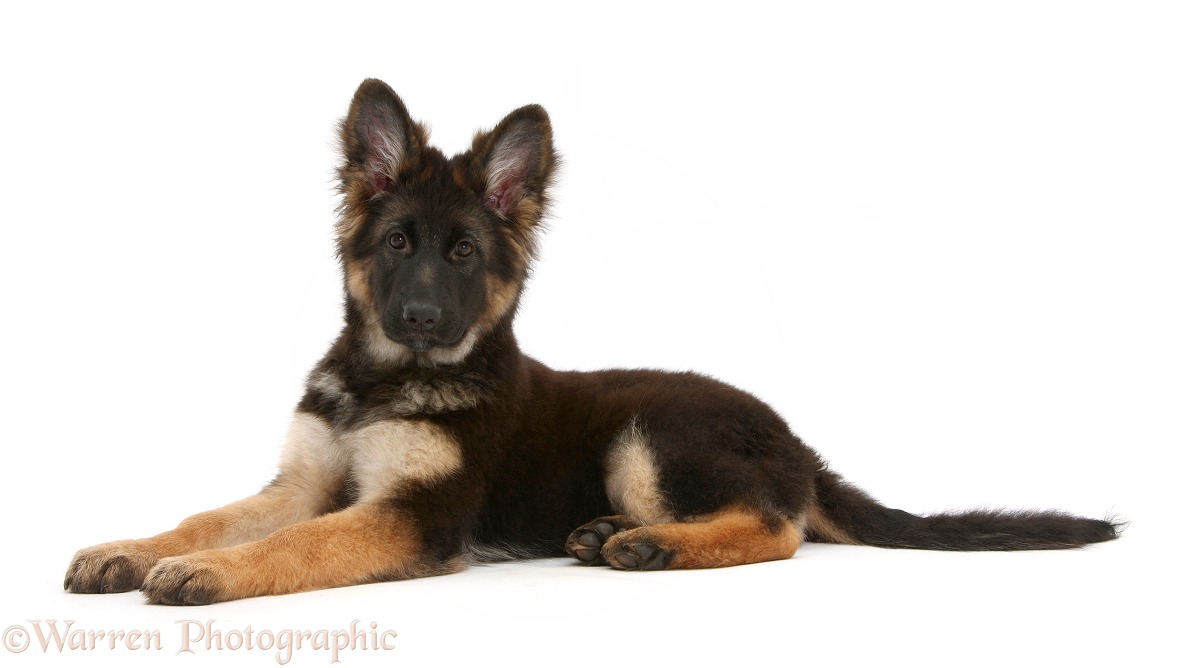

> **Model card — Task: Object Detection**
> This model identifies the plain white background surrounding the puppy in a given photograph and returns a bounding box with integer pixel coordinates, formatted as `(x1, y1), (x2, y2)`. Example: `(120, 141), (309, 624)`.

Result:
(0, 1), (1177, 666)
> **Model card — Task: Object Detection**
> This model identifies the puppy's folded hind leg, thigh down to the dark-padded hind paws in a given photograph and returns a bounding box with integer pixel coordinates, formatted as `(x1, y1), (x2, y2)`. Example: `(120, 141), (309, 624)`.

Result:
(566, 409), (818, 570)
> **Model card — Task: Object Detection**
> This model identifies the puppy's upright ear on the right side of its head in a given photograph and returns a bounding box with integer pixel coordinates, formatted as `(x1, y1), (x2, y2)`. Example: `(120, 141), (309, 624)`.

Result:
(471, 105), (557, 222)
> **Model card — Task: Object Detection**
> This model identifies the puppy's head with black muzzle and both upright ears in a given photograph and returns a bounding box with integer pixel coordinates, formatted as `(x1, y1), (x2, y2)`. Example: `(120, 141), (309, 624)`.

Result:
(337, 79), (557, 365)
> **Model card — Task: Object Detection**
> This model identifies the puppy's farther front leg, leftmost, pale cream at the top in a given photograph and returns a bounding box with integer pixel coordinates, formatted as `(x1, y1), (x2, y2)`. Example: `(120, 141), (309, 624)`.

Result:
(65, 413), (346, 594)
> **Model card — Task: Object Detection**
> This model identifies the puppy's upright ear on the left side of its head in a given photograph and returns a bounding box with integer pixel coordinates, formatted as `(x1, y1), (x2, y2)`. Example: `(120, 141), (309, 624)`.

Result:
(340, 79), (427, 195)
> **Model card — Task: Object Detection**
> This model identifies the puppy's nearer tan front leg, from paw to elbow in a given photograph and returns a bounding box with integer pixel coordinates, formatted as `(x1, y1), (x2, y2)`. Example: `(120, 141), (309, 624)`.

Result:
(135, 502), (451, 606)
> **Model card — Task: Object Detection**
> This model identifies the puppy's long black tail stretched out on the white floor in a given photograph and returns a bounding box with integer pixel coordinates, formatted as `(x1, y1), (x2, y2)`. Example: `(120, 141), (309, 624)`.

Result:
(806, 470), (1122, 552)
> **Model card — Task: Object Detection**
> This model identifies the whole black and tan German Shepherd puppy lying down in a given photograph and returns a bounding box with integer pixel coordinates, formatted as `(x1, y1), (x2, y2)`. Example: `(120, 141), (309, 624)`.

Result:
(65, 80), (1118, 604)
